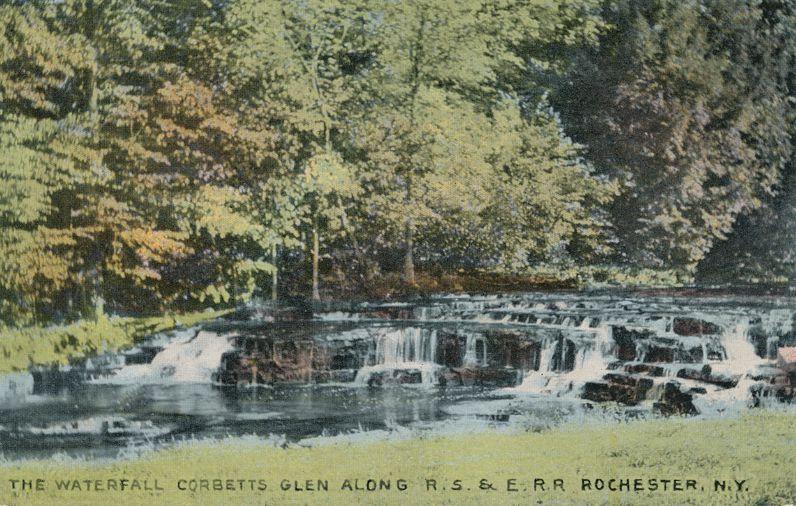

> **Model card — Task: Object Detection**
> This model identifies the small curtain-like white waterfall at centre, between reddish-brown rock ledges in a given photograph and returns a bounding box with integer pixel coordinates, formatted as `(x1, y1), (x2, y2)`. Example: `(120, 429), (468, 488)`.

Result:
(354, 327), (443, 386)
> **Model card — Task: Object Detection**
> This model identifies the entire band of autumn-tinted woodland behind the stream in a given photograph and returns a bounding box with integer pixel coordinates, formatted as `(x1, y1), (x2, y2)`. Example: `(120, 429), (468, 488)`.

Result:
(0, 0), (796, 325)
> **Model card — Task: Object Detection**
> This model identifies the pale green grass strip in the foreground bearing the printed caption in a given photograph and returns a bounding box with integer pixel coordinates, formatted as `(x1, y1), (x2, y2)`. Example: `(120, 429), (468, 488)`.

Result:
(0, 412), (796, 505)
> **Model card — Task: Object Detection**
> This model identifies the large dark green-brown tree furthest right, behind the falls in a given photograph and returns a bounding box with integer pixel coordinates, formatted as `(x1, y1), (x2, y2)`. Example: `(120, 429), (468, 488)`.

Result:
(556, 0), (790, 274)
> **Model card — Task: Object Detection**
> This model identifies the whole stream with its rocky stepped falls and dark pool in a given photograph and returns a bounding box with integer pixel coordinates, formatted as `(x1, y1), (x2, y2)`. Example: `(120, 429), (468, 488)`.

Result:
(0, 293), (796, 458)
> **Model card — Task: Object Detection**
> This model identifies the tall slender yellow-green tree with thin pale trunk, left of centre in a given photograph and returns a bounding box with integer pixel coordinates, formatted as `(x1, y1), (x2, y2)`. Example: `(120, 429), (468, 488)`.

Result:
(197, 0), (375, 299)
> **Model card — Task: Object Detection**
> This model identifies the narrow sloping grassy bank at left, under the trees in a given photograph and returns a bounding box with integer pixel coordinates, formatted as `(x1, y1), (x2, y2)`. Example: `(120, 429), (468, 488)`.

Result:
(0, 311), (228, 373)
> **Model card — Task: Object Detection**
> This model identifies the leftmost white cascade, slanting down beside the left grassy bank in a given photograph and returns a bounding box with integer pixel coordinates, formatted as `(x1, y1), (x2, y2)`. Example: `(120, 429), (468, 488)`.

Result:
(92, 330), (233, 384)
